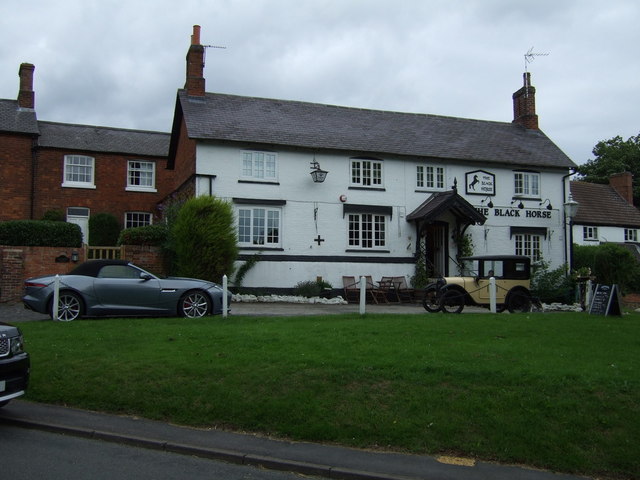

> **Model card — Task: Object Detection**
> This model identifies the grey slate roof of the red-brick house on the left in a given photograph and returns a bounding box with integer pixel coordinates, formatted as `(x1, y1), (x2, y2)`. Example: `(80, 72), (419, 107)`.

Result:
(38, 122), (170, 157)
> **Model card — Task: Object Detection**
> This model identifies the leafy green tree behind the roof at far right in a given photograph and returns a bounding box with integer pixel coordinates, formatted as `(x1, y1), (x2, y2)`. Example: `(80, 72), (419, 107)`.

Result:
(577, 134), (640, 205)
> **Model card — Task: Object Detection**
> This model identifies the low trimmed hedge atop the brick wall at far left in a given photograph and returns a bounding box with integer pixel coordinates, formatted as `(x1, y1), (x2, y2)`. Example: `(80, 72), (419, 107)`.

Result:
(0, 220), (82, 247)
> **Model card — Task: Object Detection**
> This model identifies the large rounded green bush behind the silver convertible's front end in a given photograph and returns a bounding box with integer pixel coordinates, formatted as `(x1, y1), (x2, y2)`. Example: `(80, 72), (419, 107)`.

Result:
(170, 196), (238, 282)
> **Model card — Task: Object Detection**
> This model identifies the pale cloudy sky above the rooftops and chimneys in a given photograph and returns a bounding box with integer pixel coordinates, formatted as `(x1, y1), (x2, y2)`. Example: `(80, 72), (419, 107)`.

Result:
(0, 0), (640, 164)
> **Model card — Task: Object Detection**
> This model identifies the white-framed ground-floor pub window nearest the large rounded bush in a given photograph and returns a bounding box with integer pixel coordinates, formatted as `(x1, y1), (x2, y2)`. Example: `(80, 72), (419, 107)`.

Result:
(238, 207), (281, 247)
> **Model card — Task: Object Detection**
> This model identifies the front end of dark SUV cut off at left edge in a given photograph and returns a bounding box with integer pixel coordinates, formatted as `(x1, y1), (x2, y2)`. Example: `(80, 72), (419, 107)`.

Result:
(0, 322), (31, 407)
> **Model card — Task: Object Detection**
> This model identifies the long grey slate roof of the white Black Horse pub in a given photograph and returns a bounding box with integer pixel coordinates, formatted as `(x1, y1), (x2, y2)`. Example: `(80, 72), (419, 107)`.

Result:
(170, 90), (575, 168)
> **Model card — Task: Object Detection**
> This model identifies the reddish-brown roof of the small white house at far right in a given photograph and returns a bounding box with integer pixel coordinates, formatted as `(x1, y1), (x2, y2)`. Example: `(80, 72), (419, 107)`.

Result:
(571, 181), (640, 228)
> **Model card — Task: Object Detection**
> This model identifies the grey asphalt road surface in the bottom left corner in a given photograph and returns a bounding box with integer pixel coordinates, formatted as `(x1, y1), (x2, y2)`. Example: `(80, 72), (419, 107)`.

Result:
(0, 425), (312, 480)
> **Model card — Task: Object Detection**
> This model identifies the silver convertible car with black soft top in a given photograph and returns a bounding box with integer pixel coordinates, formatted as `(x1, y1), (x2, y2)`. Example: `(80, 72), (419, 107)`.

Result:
(22, 260), (231, 321)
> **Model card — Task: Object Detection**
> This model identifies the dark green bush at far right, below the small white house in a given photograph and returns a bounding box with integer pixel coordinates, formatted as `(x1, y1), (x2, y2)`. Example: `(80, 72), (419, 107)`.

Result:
(573, 243), (640, 292)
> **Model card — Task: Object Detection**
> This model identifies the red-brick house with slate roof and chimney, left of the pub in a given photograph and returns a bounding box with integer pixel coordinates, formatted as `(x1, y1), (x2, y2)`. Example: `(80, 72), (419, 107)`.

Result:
(0, 64), (173, 241)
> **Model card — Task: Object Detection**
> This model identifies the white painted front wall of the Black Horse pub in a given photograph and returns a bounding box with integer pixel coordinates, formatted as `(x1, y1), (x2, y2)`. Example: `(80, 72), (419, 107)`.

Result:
(191, 144), (567, 288)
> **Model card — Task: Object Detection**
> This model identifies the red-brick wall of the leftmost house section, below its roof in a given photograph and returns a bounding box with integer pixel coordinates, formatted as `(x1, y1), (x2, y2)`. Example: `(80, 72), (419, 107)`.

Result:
(0, 133), (33, 221)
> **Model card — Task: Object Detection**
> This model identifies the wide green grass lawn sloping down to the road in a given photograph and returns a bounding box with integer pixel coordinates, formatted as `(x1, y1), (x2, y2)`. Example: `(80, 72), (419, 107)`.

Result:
(21, 313), (640, 478)
